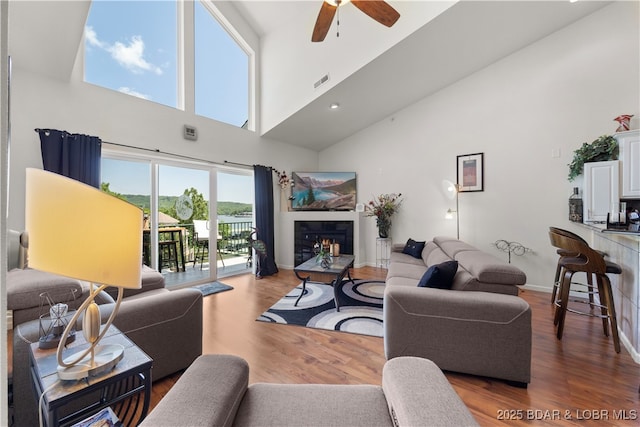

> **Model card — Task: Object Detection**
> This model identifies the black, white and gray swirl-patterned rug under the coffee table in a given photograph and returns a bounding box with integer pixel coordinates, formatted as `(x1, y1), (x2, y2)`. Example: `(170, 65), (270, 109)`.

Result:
(256, 279), (384, 337)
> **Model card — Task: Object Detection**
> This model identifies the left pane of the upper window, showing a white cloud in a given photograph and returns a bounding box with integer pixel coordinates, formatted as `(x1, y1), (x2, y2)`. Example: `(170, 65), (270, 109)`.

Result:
(84, 1), (178, 108)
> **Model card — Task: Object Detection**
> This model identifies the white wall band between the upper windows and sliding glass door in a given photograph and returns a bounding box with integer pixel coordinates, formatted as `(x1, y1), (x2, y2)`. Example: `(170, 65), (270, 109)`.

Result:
(9, 2), (318, 234)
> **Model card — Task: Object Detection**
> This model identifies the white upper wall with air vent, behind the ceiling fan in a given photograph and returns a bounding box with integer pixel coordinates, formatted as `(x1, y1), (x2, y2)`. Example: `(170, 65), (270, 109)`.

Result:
(260, 0), (457, 134)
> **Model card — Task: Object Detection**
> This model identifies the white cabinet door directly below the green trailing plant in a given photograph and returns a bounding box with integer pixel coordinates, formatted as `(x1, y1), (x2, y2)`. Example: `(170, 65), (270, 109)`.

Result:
(583, 160), (620, 222)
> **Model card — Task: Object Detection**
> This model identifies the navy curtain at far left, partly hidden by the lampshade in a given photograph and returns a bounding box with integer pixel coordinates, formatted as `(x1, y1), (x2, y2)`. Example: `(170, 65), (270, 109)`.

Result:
(36, 129), (102, 188)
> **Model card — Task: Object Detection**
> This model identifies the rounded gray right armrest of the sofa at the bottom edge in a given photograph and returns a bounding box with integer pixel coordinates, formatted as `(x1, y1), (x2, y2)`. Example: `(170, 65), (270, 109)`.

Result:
(382, 357), (478, 426)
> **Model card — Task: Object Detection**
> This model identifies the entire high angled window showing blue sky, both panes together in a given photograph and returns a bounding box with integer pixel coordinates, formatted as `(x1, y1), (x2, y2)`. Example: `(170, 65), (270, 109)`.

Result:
(84, 1), (252, 128)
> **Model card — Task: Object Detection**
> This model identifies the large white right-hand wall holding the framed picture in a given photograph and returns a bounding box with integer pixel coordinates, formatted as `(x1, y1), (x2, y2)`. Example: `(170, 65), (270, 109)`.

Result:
(320, 2), (640, 288)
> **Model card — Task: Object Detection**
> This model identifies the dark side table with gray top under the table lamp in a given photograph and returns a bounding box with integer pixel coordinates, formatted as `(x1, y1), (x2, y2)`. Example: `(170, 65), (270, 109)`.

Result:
(29, 326), (153, 427)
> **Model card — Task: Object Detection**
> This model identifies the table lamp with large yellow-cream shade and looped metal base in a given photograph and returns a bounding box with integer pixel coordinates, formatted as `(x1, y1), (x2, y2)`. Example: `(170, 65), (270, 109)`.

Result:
(25, 168), (143, 380)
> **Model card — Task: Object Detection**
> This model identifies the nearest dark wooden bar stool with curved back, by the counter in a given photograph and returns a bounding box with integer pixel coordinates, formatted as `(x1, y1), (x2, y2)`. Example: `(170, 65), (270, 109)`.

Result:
(549, 230), (622, 353)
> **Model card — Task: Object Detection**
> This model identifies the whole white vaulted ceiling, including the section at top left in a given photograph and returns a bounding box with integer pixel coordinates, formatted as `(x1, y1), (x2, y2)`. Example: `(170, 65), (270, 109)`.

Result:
(9, 0), (610, 151)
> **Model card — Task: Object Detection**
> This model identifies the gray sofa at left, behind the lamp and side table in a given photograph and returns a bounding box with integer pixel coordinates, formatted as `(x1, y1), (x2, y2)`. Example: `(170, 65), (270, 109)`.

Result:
(7, 232), (202, 426)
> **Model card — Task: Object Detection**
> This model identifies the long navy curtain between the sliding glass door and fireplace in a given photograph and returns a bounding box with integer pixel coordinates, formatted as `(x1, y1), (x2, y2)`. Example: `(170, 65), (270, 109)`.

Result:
(253, 165), (278, 276)
